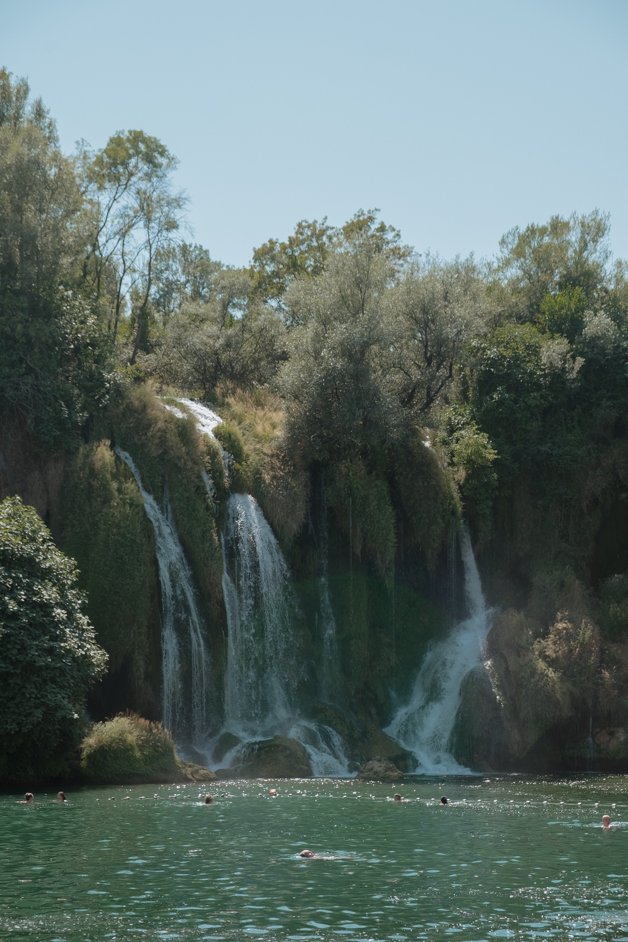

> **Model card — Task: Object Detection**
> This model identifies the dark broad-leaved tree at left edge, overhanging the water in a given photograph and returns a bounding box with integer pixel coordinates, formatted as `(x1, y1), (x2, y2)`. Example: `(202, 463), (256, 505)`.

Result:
(0, 497), (107, 780)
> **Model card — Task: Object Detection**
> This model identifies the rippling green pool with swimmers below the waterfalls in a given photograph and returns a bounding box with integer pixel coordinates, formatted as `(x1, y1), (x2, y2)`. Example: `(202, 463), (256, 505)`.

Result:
(0, 777), (628, 942)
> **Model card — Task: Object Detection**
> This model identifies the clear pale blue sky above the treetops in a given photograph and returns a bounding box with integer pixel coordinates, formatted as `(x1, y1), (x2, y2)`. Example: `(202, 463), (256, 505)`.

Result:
(0, 0), (628, 265)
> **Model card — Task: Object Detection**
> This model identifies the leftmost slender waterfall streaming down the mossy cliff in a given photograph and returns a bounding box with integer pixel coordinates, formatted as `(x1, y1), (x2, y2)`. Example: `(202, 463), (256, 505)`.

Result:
(115, 447), (210, 748)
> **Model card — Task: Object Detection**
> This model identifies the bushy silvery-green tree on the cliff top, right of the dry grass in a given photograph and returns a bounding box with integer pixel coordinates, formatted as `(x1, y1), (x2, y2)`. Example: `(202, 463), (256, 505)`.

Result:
(280, 215), (401, 462)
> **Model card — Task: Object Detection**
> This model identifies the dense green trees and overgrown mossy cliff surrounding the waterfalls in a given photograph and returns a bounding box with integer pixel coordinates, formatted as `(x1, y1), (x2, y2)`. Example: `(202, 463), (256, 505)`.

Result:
(0, 70), (628, 779)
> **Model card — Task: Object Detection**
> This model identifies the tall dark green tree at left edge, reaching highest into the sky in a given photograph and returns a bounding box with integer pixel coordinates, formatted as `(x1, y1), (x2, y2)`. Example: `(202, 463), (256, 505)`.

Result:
(0, 70), (111, 443)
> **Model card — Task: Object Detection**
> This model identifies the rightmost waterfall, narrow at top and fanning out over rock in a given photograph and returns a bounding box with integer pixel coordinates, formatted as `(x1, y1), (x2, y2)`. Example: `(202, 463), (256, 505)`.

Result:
(384, 527), (491, 774)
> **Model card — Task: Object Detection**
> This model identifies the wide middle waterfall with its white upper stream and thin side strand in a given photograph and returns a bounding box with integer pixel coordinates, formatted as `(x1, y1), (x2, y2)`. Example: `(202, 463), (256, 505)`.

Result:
(164, 399), (350, 777)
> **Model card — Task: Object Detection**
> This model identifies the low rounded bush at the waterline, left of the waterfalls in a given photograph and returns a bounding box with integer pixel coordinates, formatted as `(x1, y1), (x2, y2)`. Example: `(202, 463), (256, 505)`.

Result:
(81, 714), (179, 785)
